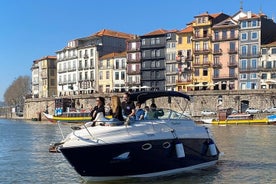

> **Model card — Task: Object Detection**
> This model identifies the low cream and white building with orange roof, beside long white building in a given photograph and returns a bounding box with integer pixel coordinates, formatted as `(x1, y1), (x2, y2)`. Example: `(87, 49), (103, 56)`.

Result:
(98, 52), (126, 93)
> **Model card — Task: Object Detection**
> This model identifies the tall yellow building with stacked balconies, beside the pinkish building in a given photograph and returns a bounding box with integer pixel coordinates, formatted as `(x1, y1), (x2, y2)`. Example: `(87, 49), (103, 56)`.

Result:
(191, 12), (229, 90)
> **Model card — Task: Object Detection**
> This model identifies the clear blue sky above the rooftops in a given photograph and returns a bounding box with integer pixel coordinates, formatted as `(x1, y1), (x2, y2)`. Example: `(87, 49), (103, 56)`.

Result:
(0, 0), (276, 101)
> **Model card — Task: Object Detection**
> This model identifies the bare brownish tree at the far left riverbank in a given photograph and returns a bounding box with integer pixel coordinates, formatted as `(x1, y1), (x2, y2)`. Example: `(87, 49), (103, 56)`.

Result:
(4, 76), (31, 107)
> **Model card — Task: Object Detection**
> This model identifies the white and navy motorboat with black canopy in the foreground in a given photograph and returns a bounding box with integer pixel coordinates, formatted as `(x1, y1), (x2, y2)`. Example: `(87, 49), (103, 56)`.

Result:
(50, 91), (220, 181)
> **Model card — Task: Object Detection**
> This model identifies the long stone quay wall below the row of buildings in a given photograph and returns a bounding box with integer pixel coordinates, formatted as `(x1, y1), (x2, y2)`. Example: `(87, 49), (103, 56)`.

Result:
(24, 89), (276, 120)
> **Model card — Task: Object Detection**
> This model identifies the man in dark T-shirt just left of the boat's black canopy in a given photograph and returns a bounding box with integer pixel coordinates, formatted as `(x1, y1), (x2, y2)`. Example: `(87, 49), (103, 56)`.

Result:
(122, 93), (135, 119)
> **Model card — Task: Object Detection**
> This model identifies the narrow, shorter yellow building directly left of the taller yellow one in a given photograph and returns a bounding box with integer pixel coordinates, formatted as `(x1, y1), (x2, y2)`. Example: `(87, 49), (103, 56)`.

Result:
(176, 25), (193, 91)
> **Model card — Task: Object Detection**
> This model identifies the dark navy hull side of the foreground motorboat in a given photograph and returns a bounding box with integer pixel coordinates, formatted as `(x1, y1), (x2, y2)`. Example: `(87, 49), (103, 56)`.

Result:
(60, 139), (219, 177)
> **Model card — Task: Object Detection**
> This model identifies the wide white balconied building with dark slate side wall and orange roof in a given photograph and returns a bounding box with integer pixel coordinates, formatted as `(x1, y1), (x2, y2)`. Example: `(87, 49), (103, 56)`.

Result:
(56, 29), (132, 96)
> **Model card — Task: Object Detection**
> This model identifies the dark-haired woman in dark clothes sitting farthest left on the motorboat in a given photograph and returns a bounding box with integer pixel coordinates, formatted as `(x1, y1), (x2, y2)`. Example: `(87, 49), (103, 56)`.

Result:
(85, 97), (105, 126)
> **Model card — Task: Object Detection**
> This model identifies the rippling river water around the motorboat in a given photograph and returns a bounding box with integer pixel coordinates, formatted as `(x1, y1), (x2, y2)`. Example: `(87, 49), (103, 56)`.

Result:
(0, 119), (276, 184)
